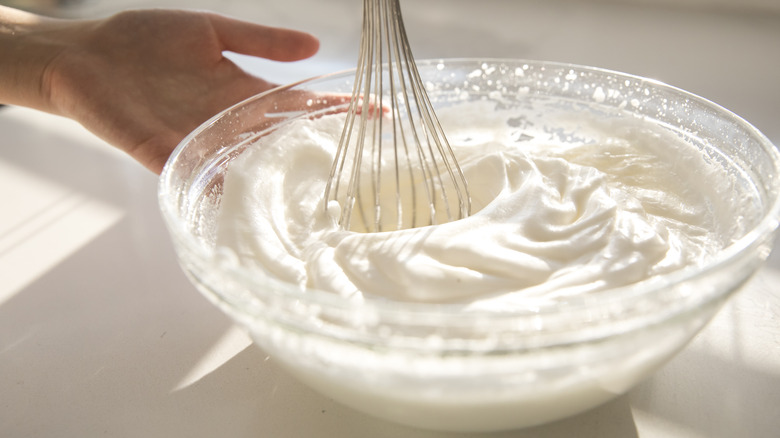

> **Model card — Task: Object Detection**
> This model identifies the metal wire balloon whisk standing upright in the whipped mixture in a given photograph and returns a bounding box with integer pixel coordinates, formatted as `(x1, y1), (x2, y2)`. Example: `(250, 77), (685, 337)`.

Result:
(325, 0), (471, 232)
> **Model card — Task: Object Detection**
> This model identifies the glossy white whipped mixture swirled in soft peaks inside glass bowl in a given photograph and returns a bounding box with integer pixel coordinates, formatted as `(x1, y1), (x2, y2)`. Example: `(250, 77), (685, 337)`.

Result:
(212, 102), (739, 308)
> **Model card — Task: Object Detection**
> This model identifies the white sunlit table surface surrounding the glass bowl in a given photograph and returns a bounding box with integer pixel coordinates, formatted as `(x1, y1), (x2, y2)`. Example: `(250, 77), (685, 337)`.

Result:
(0, 0), (780, 438)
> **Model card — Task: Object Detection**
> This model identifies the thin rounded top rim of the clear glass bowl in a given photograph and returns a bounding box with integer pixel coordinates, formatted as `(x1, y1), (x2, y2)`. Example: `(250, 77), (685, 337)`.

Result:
(158, 57), (780, 318)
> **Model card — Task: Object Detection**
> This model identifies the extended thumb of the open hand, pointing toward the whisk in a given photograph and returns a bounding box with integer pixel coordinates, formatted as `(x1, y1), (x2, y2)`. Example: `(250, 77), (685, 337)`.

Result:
(209, 14), (320, 61)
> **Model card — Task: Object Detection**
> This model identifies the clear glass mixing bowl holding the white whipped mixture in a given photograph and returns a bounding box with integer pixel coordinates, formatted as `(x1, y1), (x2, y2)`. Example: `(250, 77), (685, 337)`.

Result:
(159, 59), (780, 431)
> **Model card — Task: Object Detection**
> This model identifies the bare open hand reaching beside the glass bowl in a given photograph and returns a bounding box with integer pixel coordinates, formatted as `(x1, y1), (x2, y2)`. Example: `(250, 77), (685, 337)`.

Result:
(0, 10), (319, 173)
